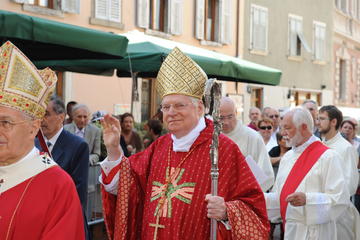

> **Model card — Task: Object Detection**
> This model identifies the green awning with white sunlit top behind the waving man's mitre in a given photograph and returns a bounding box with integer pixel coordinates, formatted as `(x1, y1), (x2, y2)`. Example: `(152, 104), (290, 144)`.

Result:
(117, 31), (281, 85)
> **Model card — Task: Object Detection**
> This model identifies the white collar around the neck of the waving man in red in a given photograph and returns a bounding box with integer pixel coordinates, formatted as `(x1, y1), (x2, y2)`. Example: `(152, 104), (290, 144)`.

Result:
(171, 117), (206, 152)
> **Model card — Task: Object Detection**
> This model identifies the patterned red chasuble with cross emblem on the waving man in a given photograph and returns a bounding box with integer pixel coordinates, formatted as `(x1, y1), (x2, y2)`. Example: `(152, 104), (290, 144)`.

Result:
(103, 120), (269, 240)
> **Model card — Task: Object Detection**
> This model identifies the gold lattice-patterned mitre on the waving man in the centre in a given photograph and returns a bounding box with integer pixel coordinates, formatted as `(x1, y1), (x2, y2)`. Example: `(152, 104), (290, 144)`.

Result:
(156, 47), (207, 99)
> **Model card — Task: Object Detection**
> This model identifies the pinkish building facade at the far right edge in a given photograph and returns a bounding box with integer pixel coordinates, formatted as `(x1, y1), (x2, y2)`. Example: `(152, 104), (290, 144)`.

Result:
(332, 0), (360, 119)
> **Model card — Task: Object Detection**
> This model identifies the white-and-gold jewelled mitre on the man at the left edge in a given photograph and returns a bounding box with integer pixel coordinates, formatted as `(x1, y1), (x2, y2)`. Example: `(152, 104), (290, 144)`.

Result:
(0, 41), (57, 118)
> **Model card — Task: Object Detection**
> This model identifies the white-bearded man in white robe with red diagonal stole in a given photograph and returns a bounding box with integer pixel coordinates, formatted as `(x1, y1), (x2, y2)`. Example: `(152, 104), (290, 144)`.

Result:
(265, 108), (355, 240)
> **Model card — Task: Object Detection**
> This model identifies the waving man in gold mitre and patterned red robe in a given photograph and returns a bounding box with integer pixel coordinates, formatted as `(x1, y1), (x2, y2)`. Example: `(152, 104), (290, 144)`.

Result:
(100, 48), (269, 240)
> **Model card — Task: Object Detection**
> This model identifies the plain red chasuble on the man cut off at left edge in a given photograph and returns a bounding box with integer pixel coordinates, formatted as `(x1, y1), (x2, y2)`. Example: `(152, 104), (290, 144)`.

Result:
(0, 166), (85, 240)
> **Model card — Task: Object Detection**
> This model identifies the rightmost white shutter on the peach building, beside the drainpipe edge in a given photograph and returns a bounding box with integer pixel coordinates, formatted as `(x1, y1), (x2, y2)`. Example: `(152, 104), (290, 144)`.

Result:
(220, 0), (232, 44)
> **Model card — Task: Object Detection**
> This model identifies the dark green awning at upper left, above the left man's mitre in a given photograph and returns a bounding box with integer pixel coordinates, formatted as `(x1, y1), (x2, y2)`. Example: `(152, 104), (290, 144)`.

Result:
(0, 10), (128, 72)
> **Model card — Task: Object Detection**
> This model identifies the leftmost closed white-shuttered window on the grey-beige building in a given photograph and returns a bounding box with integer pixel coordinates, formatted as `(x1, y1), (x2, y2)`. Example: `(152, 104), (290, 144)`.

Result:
(250, 4), (268, 51)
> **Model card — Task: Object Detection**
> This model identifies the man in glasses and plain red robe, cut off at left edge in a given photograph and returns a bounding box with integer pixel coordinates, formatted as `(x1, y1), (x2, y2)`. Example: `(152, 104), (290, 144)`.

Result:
(0, 42), (85, 240)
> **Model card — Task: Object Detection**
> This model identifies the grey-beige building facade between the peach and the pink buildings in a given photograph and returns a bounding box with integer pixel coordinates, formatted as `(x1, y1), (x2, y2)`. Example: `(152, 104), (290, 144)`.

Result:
(235, 0), (333, 124)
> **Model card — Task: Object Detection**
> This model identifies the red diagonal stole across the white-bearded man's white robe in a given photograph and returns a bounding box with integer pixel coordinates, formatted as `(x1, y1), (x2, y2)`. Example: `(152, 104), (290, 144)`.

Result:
(280, 141), (329, 225)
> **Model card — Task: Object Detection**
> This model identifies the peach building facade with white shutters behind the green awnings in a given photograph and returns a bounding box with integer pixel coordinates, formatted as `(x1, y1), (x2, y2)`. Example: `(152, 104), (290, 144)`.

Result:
(1, 0), (239, 121)
